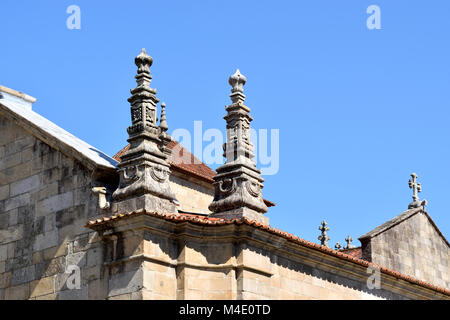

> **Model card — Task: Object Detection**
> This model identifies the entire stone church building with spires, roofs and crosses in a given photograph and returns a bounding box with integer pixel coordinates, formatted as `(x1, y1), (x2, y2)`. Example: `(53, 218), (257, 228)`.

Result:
(0, 50), (450, 299)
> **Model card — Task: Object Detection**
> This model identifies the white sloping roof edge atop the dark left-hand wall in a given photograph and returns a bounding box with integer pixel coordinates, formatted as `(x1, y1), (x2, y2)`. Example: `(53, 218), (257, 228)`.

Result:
(0, 96), (117, 171)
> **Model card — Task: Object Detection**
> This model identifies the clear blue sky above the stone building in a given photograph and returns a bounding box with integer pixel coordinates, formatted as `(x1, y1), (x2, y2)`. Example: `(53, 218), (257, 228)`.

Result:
(0, 0), (450, 246)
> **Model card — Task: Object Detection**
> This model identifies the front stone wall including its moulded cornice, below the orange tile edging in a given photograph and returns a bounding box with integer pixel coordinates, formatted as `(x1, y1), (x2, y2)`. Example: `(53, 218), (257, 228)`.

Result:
(89, 215), (450, 300)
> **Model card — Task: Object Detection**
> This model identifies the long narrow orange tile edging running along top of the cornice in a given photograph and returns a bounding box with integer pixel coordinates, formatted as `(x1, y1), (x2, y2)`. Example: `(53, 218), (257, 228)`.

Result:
(86, 209), (450, 296)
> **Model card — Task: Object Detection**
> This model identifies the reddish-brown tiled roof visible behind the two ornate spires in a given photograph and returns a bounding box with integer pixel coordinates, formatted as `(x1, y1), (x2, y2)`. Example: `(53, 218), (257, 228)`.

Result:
(113, 140), (275, 207)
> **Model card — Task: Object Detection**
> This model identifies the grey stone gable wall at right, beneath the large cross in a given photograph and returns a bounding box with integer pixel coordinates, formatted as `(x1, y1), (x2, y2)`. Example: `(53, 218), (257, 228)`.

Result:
(363, 212), (450, 288)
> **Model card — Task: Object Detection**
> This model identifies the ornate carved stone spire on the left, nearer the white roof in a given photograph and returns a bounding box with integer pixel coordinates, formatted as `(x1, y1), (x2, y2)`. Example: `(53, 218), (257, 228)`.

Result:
(113, 49), (176, 212)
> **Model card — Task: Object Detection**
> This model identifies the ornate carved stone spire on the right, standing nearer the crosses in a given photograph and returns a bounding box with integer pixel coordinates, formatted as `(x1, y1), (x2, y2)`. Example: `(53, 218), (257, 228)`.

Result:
(209, 70), (269, 224)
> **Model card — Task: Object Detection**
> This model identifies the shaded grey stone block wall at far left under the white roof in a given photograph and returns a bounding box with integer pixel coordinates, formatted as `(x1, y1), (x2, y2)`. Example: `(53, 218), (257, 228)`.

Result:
(0, 114), (107, 299)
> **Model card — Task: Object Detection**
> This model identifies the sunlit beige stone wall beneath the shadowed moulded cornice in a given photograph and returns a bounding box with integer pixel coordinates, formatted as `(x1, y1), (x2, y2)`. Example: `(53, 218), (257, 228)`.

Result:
(134, 224), (436, 300)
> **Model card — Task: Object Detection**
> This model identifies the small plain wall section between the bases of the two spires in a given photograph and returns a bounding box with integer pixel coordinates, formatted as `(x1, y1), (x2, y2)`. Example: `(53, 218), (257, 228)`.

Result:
(169, 171), (214, 213)
